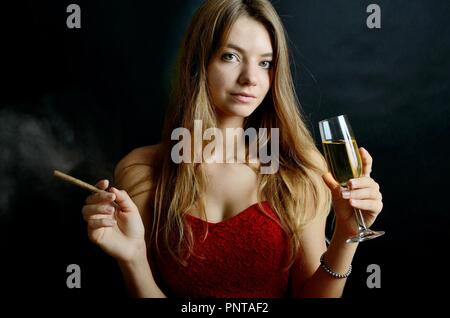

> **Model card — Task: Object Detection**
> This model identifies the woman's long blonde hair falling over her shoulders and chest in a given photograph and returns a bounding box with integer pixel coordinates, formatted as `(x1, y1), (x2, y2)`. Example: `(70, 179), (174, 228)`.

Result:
(148, 0), (331, 265)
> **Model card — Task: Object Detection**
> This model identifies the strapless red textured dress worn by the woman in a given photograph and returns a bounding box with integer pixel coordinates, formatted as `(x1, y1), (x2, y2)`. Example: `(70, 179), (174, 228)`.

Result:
(155, 201), (289, 298)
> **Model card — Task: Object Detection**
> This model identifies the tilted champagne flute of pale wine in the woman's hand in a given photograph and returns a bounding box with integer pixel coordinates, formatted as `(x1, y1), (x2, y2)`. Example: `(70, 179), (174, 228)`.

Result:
(319, 115), (384, 243)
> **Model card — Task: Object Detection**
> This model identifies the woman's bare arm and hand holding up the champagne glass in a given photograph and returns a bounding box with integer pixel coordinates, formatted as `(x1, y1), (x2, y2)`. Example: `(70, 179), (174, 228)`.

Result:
(291, 148), (383, 298)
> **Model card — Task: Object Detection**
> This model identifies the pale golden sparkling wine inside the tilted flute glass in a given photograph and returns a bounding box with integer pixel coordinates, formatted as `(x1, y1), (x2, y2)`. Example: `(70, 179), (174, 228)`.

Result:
(322, 139), (361, 187)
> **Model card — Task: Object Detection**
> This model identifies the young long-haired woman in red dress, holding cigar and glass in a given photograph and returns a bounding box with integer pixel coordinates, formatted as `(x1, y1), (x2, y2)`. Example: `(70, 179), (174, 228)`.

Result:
(83, 0), (382, 297)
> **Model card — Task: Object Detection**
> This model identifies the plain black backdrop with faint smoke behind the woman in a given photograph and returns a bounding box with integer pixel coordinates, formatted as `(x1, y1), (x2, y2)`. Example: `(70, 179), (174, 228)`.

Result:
(0, 0), (450, 299)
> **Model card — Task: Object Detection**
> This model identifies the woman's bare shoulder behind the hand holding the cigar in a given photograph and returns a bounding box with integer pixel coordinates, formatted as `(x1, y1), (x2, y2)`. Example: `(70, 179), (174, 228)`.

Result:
(114, 144), (160, 197)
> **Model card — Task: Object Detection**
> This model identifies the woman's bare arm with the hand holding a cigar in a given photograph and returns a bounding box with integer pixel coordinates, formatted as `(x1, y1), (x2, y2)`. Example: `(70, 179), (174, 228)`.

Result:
(83, 145), (165, 297)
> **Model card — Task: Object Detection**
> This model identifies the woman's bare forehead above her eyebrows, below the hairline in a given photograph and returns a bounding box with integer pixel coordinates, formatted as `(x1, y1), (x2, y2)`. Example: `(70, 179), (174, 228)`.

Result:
(225, 17), (272, 54)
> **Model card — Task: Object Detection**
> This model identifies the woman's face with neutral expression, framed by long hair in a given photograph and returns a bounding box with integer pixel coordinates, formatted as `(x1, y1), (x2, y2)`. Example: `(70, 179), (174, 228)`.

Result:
(208, 17), (272, 117)
